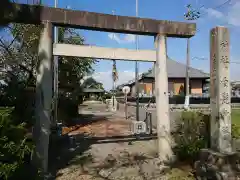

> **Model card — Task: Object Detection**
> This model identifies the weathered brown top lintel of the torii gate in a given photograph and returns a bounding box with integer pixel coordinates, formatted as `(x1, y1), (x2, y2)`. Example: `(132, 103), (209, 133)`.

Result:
(0, 3), (196, 38)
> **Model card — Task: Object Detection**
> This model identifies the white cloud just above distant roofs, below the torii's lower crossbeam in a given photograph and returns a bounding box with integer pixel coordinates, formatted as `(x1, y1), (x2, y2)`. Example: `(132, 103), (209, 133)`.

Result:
(92, 71), (141, 90)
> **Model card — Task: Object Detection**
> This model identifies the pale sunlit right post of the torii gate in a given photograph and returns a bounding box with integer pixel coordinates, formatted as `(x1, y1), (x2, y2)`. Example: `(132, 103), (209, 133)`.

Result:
(155, 35), (173, 161)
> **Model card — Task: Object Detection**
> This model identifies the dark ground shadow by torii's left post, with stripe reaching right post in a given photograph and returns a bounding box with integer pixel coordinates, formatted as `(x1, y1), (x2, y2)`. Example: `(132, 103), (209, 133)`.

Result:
(49, 114), (157, 179)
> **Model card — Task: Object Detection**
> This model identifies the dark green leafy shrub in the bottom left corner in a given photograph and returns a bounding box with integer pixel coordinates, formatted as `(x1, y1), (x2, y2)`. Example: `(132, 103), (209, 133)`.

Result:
(0, 108), (33, 180)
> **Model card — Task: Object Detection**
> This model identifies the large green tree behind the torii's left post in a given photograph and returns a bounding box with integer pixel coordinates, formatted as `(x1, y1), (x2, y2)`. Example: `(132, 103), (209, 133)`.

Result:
(0, 24), (95, 125)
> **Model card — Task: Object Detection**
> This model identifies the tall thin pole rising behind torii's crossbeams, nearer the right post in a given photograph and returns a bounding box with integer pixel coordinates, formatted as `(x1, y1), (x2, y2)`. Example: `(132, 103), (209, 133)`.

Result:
(135, 0), (139, 121)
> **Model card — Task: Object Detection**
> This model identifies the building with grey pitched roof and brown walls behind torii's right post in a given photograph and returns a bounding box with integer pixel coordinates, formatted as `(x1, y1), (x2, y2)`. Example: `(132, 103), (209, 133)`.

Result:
(118, 58), (210, 96)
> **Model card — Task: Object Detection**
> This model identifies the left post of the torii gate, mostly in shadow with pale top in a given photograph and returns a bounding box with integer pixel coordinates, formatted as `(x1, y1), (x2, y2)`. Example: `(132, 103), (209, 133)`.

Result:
(34, 22), (53, 173)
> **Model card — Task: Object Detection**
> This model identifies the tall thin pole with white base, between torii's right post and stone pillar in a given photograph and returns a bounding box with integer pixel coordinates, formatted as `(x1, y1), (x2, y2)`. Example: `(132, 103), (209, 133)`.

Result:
(184, 38), (190, 109)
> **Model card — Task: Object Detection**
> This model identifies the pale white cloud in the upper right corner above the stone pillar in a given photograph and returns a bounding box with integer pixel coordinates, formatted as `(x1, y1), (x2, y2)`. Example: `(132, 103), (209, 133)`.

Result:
(204, 1), (240, 27)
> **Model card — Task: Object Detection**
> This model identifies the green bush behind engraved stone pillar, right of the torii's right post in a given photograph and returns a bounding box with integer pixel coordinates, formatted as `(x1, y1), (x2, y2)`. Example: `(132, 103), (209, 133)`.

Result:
(173, 111), (240, 161)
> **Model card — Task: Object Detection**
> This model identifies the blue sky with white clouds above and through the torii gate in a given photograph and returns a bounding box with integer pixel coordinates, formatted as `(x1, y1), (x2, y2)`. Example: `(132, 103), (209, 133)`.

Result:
(36, 0), (240, 89)
